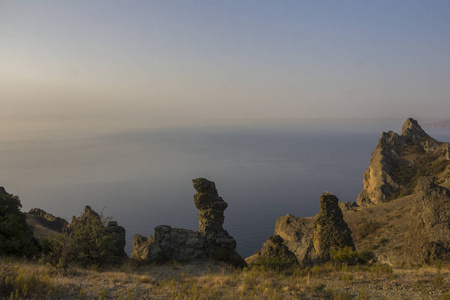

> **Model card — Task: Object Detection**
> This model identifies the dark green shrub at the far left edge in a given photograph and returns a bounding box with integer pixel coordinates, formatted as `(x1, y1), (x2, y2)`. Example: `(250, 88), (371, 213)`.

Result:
(0, 187), (37, 257)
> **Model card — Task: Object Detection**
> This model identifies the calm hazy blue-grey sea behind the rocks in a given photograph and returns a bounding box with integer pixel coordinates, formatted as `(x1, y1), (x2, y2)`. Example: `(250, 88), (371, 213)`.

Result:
(0, 121), (450, 257)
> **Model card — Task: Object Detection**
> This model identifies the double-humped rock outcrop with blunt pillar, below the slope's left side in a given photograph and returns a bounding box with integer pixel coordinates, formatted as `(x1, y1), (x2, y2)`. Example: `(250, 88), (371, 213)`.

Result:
(261, 193), (355, 265)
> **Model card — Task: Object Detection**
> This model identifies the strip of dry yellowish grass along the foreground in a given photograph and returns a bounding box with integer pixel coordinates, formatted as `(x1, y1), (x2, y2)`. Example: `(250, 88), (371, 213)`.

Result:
(0, 259), (450, 299)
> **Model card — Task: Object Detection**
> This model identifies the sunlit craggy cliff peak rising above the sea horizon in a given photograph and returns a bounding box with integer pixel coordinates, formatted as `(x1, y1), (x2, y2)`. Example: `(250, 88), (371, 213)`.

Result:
(357, 118), (450, 206)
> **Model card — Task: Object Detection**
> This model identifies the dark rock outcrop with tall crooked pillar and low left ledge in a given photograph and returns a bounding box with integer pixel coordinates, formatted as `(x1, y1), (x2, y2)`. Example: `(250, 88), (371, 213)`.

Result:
(131, 178), (246, 267)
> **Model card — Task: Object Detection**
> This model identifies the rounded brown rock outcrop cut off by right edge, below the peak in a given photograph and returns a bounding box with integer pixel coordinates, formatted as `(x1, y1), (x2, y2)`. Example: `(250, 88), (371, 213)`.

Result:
(409, 177), (450, 263)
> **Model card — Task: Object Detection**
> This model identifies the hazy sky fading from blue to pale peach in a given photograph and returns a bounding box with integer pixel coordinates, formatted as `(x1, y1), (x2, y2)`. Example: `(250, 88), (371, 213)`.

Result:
(0, 0), (450, 130)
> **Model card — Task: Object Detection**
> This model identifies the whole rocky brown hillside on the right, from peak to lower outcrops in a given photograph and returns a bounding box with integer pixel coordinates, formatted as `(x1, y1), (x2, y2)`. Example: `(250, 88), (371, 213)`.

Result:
(255, 119), (450, 266)
